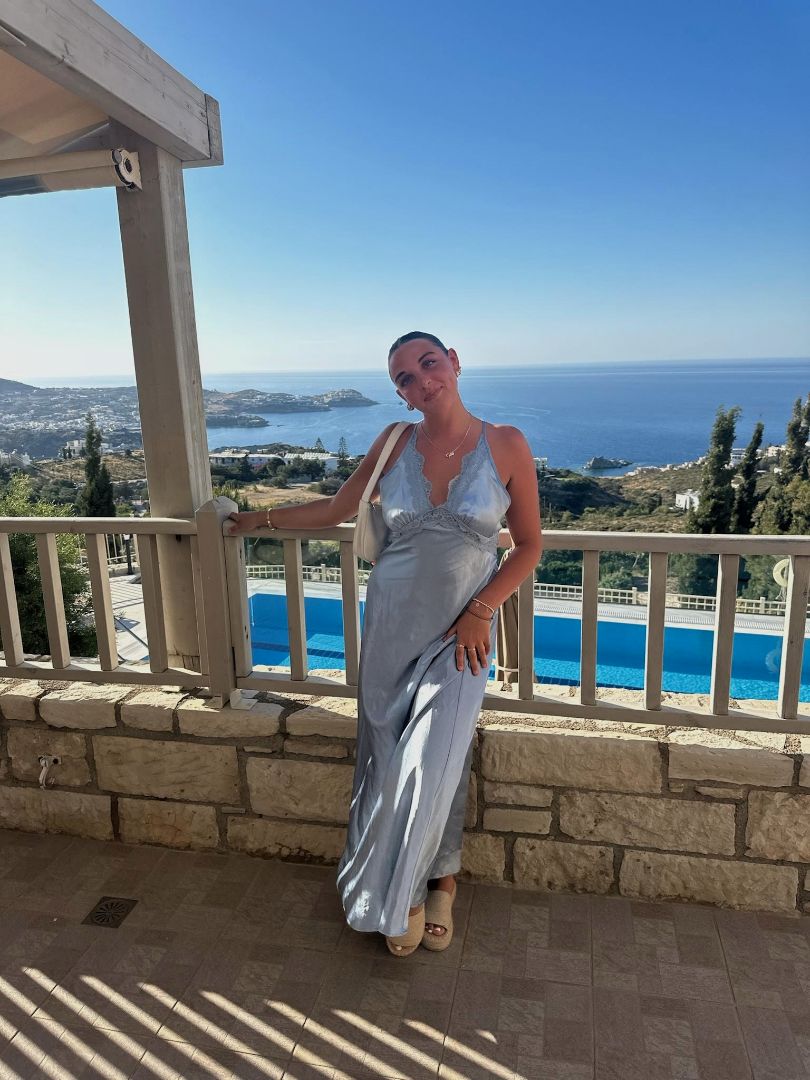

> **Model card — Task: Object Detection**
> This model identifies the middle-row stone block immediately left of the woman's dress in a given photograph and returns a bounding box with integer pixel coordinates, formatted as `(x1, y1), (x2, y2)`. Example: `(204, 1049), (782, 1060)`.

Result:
(247, 757), (354, 824)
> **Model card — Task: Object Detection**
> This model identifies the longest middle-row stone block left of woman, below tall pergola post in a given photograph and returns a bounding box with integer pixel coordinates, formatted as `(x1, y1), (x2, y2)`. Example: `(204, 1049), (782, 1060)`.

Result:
(93, 735), (241, 804)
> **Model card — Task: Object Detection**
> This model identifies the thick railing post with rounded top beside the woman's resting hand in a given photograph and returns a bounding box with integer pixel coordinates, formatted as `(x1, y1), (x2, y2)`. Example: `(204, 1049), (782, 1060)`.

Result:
(194, 496), (239, 702)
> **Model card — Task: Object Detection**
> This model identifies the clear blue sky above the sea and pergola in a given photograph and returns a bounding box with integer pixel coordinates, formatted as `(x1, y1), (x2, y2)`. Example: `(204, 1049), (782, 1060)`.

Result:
(0, 0), (810, 378)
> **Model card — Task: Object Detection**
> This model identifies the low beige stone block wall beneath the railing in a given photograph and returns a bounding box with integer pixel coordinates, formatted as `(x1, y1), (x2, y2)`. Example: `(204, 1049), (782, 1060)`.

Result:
(0, 680), (810, 912)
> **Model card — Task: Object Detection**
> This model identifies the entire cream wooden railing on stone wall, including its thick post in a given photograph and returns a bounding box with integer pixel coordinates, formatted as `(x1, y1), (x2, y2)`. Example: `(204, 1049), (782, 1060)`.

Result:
(0, 499), (810, 733)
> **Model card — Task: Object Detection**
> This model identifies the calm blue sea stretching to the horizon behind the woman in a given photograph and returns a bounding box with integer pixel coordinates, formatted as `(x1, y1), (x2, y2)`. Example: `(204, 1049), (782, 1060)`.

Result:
(27, 357), (810, 474)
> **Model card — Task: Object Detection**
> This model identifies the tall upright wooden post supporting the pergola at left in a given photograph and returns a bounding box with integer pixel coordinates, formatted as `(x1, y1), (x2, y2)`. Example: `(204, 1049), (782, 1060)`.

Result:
(118, 130), (212, 670)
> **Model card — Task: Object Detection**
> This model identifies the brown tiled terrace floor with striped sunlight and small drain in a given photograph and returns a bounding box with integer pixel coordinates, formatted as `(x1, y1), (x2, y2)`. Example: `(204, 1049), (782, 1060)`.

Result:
(0, 831), (810, 1080)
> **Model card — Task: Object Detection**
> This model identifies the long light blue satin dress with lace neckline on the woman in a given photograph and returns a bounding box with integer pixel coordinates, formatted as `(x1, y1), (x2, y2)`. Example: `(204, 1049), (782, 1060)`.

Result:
(338, 424), (510, 936)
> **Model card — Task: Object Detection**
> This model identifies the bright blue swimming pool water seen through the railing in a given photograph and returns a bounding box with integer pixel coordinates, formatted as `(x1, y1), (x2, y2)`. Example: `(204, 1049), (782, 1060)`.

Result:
(251, 593), (810, 701)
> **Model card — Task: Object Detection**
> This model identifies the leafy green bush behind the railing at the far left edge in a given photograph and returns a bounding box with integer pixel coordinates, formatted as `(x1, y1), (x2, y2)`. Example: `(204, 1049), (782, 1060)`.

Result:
(0, 473), (97, 657)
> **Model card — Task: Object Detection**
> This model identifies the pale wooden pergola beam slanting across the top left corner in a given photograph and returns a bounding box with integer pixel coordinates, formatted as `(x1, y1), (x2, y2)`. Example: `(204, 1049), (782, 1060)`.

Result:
(0, 0), (222, 165)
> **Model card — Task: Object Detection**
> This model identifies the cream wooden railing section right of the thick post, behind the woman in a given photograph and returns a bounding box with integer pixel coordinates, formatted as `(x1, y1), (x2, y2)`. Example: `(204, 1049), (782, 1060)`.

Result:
(226, 526), (810, 733)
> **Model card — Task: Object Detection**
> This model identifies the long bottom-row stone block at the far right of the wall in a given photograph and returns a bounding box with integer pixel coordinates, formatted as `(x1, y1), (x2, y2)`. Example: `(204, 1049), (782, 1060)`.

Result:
(619, 851), (799, 912)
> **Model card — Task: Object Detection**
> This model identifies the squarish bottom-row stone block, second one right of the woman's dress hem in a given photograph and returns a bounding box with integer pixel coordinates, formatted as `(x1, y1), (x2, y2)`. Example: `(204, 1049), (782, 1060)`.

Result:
(514, 839), (613, 893)
